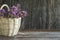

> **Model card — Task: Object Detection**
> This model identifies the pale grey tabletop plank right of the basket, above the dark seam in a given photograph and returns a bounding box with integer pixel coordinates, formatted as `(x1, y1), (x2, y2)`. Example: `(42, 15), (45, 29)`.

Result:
(17, 32), (60, 38)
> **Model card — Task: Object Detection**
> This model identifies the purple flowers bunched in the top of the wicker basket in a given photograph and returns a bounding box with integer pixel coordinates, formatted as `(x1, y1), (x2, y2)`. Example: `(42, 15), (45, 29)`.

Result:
(0, 6), (27, 18)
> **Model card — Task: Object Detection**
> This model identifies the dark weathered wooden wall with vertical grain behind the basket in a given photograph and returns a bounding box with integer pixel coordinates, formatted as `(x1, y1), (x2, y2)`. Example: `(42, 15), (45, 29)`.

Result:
(0, 0), (60, 30)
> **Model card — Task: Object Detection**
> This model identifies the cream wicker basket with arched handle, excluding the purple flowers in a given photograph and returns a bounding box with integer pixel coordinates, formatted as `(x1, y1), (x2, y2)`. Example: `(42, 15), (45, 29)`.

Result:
(0, 4), (21, 36)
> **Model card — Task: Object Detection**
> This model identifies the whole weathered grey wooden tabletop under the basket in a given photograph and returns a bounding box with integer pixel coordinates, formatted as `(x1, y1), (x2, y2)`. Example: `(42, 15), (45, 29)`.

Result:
(0, 32), (60, 40)
